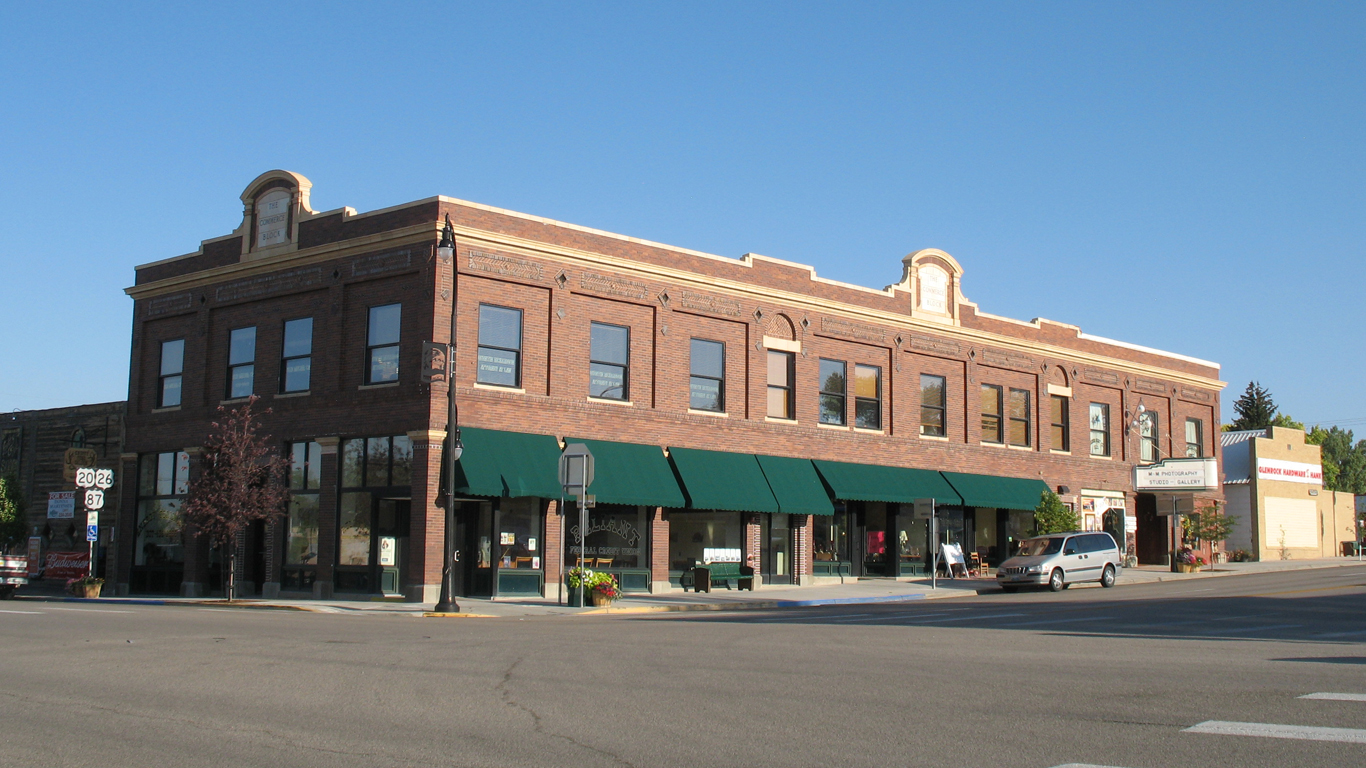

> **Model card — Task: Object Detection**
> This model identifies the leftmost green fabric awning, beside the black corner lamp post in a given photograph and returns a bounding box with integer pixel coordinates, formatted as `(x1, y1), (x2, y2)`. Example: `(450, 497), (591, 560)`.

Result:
(455, 426), (560, 499)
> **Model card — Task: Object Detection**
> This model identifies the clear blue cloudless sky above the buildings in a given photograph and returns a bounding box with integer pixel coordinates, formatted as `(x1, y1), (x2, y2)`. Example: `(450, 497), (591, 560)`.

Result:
(0, 0), (1366, 423)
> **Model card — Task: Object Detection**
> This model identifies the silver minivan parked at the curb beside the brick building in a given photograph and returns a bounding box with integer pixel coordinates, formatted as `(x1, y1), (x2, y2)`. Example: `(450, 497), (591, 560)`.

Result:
(996, 530), (1123, 592)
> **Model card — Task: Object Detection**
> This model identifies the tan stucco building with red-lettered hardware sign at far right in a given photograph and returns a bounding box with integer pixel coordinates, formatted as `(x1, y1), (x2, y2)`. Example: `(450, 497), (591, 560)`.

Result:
(1220, 426), (1356, 560)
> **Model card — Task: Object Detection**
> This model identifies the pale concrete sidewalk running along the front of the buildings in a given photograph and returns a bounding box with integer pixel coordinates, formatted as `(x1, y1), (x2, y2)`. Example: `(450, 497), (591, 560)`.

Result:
(15, 549), (1366, 619)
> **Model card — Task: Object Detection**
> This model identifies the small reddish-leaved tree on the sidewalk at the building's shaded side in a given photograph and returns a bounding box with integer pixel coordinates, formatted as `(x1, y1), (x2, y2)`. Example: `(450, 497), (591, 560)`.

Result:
(183, 395), (288, 600)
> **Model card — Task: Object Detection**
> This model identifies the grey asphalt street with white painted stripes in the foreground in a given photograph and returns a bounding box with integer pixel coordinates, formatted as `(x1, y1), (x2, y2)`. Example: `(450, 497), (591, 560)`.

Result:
(0, 567), (1366, 768)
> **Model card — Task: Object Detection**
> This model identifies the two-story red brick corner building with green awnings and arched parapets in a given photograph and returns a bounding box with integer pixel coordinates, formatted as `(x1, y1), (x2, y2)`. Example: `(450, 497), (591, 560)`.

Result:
(117, 171), (1224, 601)
